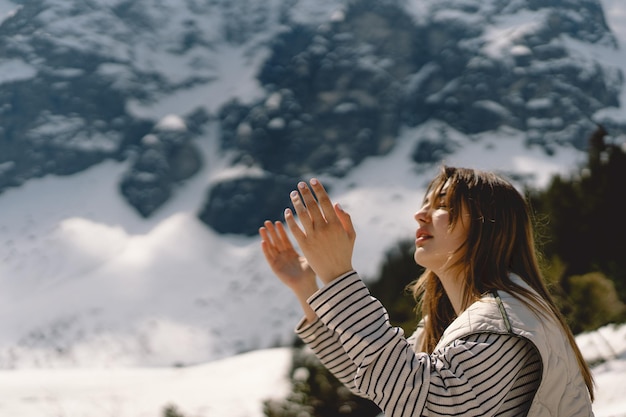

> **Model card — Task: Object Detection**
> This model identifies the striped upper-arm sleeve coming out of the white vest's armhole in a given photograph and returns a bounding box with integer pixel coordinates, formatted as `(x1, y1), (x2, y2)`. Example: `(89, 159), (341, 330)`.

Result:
(425, 333), (541, 416)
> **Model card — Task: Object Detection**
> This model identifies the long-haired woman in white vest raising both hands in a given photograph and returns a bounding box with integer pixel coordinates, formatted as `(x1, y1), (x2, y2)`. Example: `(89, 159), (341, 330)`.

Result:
(259, 167), (593, 417)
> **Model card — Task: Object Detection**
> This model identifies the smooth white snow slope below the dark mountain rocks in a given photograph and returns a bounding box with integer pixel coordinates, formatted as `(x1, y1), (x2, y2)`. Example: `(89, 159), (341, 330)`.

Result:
(0, 118), (582, 368)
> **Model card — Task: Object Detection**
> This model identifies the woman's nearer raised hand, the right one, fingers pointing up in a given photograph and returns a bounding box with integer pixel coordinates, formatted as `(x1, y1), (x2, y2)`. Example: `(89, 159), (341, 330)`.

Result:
(285, 178), (356, 283)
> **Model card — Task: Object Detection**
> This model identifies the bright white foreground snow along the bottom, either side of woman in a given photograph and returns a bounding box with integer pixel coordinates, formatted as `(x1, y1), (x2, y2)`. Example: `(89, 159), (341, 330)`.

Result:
(0, 326), (626, 417)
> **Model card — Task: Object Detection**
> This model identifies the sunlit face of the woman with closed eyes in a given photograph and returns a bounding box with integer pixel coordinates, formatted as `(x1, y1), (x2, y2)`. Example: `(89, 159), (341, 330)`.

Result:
(414, 185), (469, 276)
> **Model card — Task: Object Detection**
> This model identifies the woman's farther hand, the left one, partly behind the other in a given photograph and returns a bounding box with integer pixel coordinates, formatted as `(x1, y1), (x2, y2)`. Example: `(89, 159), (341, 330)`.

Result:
(259, 221), (317, 298)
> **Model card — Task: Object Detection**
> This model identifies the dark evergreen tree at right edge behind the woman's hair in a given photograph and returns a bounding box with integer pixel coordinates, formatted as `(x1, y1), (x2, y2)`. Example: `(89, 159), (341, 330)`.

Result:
(530, 126), (626, 324)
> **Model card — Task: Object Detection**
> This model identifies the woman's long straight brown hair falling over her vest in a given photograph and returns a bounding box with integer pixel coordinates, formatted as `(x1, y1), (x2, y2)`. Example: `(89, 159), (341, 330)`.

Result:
(411, 166), (594, 401)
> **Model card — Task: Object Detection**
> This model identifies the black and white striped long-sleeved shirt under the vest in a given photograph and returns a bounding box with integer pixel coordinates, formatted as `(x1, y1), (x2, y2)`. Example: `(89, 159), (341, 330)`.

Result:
(296, 272), (541, 417)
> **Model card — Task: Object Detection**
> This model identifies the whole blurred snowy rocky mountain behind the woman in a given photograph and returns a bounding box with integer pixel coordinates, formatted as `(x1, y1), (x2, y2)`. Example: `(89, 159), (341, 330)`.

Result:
(0, 0), (626, 376)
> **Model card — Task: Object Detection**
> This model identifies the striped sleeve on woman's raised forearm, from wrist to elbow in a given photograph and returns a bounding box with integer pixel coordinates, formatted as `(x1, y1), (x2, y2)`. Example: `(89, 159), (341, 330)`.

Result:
(309, 272), (430, 417)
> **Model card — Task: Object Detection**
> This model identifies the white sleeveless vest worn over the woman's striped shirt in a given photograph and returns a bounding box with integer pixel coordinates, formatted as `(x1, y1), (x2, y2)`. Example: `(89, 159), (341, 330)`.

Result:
(435, 275), (593, 417)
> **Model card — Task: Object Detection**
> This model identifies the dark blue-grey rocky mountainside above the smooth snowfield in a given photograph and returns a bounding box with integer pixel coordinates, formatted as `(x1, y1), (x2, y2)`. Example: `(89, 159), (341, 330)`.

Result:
(0, 0), (623, 235)
